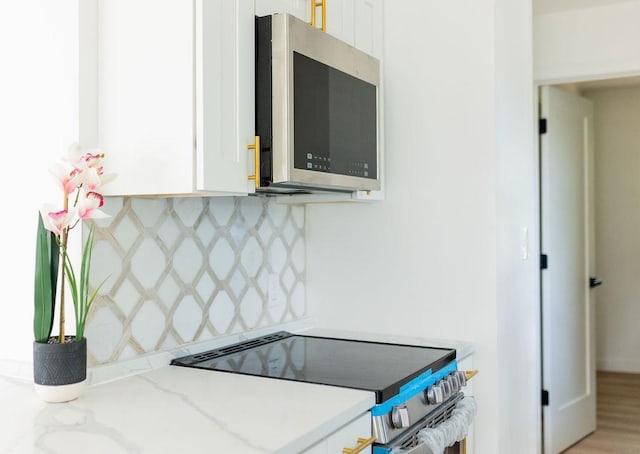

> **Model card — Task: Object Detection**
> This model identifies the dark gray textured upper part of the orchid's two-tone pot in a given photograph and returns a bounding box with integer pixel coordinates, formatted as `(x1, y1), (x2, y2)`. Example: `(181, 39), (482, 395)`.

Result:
(33, 338), (87, 386)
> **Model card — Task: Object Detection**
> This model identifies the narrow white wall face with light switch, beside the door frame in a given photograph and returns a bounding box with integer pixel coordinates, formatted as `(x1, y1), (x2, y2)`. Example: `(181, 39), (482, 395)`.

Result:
(496, 0), (541, 453)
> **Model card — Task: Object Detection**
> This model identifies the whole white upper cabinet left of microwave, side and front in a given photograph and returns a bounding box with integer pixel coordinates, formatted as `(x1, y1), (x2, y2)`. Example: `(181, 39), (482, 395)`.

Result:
(96, 0), (255, 196)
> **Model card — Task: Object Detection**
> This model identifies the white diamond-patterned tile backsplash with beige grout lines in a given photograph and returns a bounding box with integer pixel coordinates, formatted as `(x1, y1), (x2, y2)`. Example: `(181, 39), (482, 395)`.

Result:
(86, 197), (307, 366)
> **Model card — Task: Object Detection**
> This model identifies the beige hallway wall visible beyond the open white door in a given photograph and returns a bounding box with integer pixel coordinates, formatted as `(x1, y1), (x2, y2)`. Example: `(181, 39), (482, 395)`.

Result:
(583, 87), (640, 373)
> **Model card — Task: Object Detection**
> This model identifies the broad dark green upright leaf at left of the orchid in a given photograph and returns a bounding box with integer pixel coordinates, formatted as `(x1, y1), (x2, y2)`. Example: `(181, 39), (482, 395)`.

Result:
(33, 213), (59, 342)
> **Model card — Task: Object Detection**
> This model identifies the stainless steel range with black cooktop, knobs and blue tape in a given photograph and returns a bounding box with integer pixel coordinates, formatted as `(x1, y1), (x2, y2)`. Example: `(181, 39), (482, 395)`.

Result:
(172, 331), (475, 454)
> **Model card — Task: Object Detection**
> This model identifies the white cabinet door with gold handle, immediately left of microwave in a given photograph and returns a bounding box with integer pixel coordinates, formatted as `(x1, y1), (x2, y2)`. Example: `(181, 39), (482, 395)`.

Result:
(195, 0), (255, 194)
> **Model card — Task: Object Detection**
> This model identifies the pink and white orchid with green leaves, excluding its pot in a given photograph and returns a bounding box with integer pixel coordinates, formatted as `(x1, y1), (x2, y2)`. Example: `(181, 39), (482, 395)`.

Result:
(34, 143), (114, 343)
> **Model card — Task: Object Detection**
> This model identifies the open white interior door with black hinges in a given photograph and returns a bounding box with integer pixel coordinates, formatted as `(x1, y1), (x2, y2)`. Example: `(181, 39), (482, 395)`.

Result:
(540, 87), (596, 454)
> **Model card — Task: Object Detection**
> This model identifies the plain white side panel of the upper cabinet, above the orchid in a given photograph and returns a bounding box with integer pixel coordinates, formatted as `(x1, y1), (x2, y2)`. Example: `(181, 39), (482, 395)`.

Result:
(98, 0), (194, 195)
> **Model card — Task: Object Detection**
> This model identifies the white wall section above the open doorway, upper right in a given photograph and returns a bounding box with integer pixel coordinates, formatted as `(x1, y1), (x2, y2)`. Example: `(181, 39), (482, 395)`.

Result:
(534, 0), (640, 84)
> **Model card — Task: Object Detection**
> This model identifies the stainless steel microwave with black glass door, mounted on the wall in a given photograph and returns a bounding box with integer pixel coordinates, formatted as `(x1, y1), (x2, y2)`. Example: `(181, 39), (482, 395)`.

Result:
(256, 14), (380, 193)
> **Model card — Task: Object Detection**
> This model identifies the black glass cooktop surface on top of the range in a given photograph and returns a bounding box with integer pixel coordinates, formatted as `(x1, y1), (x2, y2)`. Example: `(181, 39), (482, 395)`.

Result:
(171, 331), (456, 403)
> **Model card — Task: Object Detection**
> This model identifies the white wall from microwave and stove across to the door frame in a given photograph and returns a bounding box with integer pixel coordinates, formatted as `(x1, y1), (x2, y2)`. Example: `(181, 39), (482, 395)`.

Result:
(307, 0), (540, 453)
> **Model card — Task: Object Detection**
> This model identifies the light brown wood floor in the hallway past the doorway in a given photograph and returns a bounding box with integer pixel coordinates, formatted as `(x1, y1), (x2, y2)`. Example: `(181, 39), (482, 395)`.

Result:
(564, 372), (640, 454)
